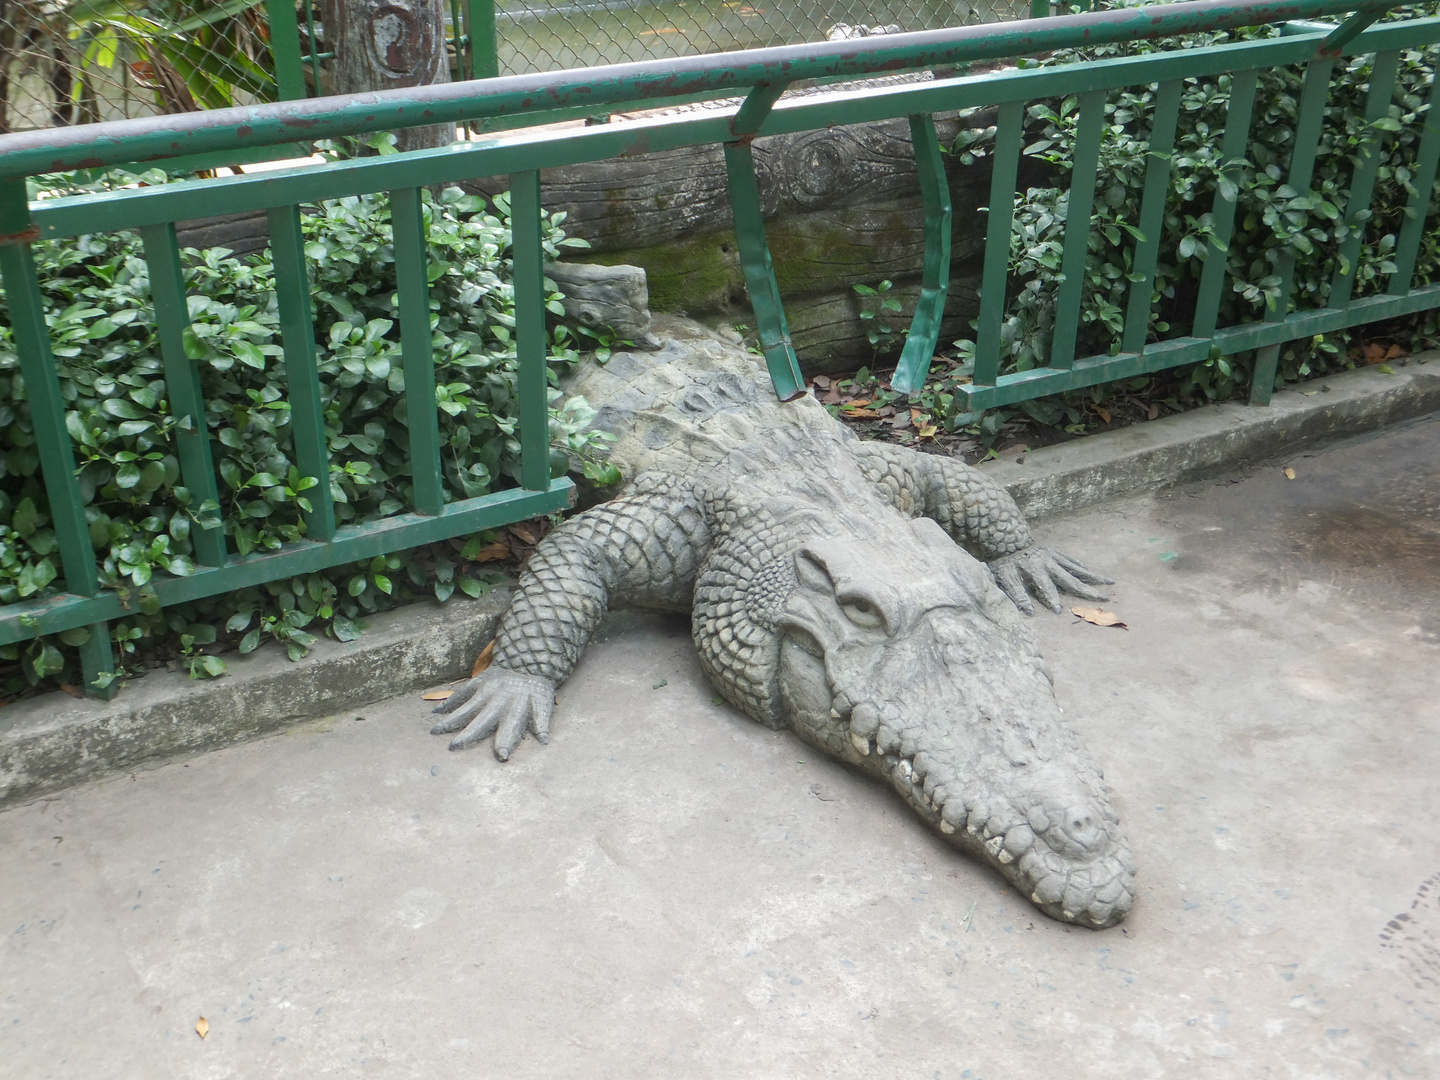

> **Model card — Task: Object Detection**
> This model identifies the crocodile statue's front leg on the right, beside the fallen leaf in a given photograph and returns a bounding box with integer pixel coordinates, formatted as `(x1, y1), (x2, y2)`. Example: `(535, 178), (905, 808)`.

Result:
(855, 442), (1112, 615)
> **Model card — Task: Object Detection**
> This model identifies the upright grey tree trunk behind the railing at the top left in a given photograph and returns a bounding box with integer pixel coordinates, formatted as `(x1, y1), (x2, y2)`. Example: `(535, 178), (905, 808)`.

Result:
(325, 0), (455, 150)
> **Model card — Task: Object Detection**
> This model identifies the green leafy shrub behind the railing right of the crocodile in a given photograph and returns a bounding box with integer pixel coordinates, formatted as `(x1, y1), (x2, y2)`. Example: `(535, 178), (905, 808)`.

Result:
(952, 19), (1440, 423)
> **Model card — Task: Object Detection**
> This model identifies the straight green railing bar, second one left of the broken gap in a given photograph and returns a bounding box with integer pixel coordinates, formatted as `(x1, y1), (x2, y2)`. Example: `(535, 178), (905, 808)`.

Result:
(390, 187), (445, 514)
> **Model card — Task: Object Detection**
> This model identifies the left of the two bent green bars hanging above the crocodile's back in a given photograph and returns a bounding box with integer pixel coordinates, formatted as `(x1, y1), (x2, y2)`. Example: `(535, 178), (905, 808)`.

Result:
(724, 141), (805, 402)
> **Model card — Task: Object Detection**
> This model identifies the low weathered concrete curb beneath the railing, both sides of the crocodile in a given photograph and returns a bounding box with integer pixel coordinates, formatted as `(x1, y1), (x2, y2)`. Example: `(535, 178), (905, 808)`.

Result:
(0, 357), (1440, 806)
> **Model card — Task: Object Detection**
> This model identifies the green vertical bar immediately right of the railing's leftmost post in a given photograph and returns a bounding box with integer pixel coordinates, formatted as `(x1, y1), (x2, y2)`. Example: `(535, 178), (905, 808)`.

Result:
(140, 223), (225, 566)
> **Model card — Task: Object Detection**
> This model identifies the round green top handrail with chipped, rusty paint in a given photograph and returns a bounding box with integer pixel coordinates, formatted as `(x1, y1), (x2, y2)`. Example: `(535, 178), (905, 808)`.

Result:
(0, 0), (1404, 180)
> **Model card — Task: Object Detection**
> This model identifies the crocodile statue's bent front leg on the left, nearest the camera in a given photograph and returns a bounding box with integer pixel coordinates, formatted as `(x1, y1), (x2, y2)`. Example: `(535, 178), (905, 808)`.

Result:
(431, 478), (708, 762)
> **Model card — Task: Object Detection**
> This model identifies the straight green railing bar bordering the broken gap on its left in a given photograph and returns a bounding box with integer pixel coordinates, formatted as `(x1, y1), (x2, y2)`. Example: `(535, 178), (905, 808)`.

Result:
(510, 170), (550, 491)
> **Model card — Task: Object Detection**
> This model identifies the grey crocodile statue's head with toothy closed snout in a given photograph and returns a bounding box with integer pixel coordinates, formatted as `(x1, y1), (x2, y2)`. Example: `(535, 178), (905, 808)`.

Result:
(775, 518), (1135, 929)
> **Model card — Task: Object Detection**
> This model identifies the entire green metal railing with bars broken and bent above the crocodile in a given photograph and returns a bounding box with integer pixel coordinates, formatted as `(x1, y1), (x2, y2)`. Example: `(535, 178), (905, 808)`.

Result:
(0, 0), (1440, 693)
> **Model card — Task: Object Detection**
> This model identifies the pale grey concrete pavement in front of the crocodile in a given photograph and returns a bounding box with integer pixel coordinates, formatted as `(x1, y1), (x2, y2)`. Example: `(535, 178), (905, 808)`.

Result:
(0, 419), (1440, 1080)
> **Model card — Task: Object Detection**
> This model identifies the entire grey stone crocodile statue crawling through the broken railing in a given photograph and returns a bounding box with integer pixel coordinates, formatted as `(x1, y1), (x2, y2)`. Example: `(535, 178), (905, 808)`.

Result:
(433, 320), (1135, 927)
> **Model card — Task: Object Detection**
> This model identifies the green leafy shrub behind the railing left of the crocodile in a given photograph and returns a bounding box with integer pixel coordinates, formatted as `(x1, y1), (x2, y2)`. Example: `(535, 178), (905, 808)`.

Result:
(0, 180), (603, 693)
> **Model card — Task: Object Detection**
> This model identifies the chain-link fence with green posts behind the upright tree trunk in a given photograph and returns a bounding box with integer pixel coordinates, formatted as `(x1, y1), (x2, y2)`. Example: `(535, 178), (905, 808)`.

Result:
(0, 0), (1030, 131)
